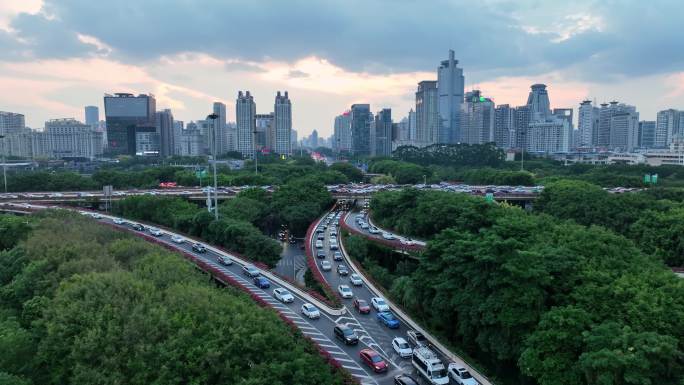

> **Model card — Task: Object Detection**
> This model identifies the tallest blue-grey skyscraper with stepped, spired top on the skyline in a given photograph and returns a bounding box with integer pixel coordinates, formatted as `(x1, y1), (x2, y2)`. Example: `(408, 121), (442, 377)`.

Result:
(437, 50), (465, 143)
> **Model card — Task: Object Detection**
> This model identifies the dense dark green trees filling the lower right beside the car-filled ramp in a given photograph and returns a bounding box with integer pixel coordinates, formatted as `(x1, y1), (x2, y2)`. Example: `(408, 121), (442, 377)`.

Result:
(368, 189), (684, 385)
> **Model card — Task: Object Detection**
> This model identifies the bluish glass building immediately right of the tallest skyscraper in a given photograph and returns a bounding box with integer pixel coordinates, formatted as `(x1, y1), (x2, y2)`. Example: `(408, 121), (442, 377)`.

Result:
(458, 90), (495, 144)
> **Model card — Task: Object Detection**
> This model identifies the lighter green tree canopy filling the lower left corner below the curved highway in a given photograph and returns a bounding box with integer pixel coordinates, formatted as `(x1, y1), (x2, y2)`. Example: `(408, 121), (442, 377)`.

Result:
(0, 213), (343, 385)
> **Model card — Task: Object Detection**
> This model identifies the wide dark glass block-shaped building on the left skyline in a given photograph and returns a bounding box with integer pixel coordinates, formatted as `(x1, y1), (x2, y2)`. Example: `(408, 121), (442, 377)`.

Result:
(104, 93), (158, 155)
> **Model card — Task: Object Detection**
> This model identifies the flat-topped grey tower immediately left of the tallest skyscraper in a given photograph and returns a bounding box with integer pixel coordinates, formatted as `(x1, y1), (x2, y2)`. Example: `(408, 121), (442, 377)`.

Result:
(414, 80), (440, 147)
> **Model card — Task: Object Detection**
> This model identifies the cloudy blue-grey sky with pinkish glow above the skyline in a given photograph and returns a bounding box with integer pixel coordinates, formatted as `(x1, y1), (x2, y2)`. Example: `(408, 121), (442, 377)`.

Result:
(0, 0), (684, 137)
